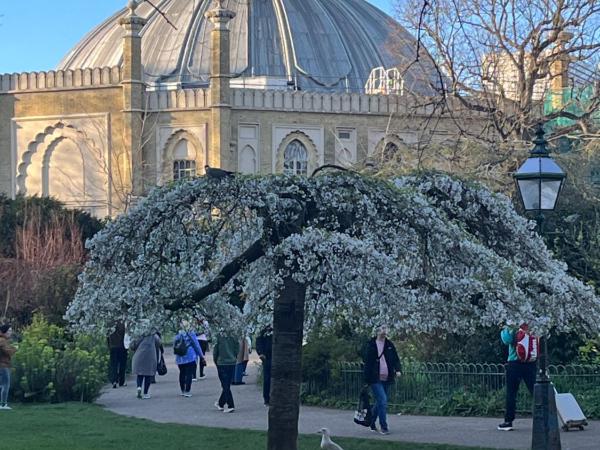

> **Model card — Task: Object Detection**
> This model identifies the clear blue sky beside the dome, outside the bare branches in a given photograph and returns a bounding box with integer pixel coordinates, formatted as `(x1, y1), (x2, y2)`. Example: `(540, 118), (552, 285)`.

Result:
(0, 0), (392, 73)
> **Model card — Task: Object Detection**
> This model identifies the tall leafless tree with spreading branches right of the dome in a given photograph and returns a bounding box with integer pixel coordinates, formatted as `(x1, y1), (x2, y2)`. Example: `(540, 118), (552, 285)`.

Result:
(396, 0), (600, 142)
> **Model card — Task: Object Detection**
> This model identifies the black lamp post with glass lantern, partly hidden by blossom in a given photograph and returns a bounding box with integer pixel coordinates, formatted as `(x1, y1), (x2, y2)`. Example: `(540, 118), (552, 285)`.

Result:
(514, 123), (566, 450)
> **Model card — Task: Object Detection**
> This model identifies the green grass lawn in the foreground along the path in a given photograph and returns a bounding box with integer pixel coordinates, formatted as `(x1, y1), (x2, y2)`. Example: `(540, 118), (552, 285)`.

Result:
(0, 403), (496, 450)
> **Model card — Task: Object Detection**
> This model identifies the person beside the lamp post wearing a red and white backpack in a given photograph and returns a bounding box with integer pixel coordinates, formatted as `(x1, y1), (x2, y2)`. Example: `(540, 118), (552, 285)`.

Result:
(498, 323), (539, 431)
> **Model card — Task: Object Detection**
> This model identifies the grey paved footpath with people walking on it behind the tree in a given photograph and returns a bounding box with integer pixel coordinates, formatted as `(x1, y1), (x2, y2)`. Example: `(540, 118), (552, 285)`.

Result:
(97, 348), (600, 450)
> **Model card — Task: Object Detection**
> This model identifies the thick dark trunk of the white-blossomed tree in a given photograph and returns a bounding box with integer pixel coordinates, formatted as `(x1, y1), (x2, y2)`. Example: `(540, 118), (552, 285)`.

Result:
(267, 261), (306, 450)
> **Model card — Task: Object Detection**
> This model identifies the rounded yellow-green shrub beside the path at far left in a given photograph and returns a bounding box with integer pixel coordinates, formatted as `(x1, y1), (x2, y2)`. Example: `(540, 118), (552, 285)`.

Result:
(13, 315), (108, 402)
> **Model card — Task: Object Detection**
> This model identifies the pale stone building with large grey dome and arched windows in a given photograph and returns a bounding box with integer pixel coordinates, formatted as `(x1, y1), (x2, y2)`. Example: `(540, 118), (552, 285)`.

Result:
(0, 0), (450, 216)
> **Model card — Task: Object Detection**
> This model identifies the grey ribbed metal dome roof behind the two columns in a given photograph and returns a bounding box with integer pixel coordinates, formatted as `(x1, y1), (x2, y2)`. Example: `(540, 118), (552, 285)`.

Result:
(58, 0), (435, 93)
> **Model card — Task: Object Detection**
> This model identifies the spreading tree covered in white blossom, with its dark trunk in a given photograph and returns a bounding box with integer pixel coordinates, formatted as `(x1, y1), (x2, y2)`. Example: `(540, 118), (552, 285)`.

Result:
(67, 172), (600, 450)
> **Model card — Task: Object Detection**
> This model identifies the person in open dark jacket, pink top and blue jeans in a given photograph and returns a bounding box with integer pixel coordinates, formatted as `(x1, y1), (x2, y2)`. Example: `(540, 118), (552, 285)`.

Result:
(364, 326), (401, 434)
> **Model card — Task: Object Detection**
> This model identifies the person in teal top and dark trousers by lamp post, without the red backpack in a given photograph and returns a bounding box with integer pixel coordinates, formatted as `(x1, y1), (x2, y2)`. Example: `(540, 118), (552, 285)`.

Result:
(498, 323), (536, 431)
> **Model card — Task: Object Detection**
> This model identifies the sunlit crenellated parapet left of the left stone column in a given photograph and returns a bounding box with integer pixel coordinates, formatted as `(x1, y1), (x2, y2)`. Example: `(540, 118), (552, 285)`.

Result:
(0, 66), (122, 92)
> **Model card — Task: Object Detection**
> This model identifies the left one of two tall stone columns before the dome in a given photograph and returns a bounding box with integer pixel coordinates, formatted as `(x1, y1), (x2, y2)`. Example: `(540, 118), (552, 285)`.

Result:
(118, 0), (147, 197)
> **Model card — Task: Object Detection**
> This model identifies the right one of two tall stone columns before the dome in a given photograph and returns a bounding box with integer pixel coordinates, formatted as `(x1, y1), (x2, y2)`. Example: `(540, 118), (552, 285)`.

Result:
(206, 0), (237, 170)
